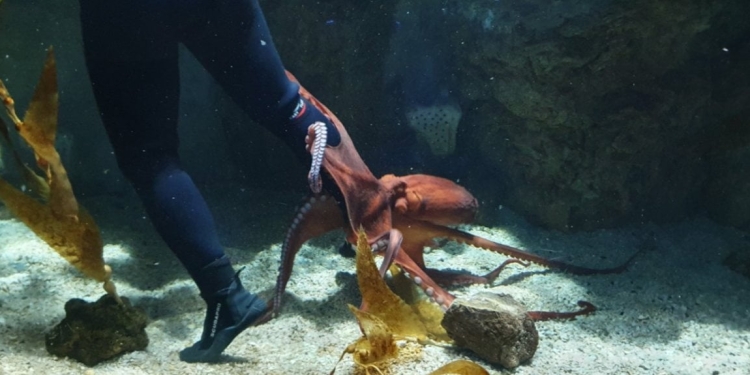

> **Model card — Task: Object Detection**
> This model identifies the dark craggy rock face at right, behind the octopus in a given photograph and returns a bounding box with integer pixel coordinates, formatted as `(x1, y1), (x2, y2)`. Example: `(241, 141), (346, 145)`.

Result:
(446, 1), (748, 230)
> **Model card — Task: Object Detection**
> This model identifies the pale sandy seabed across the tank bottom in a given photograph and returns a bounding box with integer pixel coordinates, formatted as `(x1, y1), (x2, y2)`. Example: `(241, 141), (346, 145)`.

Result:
(0, 185), (750, 375)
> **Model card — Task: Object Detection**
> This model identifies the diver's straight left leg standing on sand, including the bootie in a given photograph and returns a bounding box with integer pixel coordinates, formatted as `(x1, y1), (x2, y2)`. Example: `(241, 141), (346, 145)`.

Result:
(81, 0), (266, 362)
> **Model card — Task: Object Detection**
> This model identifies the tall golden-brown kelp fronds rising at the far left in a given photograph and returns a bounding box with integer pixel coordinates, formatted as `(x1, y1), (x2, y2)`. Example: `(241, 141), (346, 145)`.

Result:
(0, 48), (120, 301)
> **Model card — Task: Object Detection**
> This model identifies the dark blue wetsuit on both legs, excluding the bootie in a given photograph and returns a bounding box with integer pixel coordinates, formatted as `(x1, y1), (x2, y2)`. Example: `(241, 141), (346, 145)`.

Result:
(80, 0), (337, 294)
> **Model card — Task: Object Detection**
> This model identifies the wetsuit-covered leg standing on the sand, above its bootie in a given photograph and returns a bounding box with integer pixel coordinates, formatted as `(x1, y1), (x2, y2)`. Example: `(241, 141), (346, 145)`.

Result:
(81, 0), (224, 288)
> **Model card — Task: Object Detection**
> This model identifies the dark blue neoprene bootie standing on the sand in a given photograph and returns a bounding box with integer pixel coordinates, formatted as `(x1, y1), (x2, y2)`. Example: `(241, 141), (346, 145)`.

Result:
(180, 257), (268, 362)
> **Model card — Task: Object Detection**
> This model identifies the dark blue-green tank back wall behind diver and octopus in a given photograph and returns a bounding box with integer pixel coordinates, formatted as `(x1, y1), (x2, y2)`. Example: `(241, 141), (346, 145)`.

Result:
(0, 0), (750, 231)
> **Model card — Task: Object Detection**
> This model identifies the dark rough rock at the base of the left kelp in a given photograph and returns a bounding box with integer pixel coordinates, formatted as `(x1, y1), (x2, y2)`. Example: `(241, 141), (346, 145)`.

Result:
(45, 295), (148, 366)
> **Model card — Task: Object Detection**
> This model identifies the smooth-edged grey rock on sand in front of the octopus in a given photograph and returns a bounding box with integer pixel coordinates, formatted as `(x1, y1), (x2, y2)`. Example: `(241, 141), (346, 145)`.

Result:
(442, 292), (539, 369)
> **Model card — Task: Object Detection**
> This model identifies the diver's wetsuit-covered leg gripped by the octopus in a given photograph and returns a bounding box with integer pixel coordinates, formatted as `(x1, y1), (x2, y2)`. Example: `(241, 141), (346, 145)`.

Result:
(180, 0), (339, 162)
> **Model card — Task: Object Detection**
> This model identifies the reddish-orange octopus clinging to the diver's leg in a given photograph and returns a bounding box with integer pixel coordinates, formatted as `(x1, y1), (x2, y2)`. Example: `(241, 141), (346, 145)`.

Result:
(270, 72), (637, 320)
